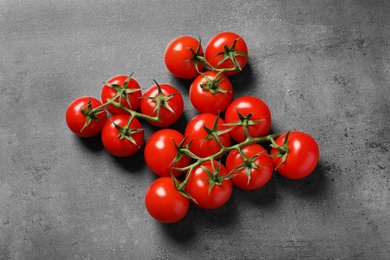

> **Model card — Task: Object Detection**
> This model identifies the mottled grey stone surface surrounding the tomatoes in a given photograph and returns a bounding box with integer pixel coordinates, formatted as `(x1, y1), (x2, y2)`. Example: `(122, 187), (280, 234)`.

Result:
(0, 0), (390, 259)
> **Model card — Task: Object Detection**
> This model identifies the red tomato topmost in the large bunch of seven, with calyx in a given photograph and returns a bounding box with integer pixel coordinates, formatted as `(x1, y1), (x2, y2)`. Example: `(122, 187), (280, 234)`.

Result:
(225, 96), (271, 142)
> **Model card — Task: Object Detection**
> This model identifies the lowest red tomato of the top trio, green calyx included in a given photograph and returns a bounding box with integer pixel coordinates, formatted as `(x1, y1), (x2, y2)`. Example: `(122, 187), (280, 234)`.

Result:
(189, 71), (233, 114)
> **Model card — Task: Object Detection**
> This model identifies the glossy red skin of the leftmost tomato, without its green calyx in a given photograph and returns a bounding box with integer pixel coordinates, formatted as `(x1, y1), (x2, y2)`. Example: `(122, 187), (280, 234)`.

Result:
(65, 96), (107, 137)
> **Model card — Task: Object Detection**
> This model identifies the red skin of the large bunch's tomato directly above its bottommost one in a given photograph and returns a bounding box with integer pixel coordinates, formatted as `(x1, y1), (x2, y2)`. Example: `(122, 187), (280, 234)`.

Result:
(144, 128), (191, 177)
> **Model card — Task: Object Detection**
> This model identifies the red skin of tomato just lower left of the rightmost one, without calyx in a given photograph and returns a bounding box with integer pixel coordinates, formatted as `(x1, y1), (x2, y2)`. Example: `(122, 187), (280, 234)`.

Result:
(226, 143), (274, 190)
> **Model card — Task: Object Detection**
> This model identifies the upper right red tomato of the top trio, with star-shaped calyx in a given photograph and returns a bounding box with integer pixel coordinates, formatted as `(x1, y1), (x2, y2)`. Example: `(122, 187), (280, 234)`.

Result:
(205, 32), (248, 76)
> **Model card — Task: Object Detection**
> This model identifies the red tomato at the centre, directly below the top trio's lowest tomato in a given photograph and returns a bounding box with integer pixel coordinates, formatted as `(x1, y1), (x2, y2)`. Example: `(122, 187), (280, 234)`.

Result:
(184, 113), (230, 158)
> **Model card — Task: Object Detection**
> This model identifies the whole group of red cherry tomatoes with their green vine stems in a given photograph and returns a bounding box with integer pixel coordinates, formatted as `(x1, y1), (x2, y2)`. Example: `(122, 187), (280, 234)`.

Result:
(66, 32), (319, 223)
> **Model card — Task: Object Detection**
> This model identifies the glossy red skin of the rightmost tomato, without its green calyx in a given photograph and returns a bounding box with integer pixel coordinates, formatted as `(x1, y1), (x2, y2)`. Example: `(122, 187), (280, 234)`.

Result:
(270, 131), (320, 180)
